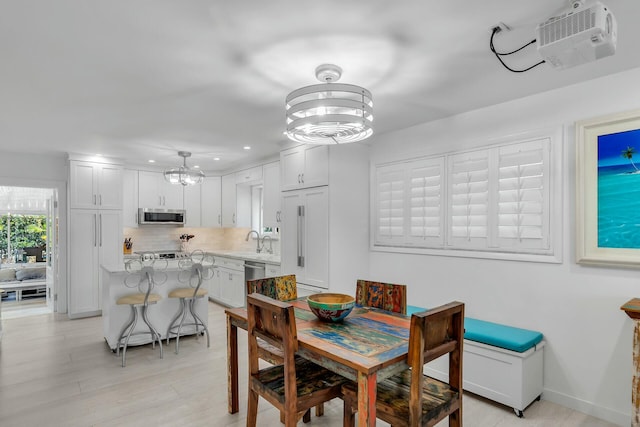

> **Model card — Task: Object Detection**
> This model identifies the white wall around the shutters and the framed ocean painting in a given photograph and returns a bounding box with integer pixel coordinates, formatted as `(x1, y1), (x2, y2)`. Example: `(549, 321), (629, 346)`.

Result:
(369, 69), (640, 425)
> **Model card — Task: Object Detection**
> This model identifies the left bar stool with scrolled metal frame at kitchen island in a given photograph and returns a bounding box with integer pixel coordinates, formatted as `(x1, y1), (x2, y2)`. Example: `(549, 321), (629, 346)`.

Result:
(116, 260), (167, 368)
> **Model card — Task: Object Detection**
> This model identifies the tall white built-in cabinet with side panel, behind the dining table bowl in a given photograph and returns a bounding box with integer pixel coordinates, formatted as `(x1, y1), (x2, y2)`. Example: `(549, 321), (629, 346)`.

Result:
(280, 144), (369, 294)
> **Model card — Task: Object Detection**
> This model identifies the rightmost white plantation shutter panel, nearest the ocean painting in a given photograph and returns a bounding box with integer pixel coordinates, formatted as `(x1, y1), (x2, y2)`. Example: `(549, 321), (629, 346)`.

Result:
(496, 138), (550, 250)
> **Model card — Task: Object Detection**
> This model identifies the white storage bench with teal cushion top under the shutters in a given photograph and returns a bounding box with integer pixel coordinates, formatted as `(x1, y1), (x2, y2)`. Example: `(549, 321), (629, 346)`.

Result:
(407, 307), (545, 417)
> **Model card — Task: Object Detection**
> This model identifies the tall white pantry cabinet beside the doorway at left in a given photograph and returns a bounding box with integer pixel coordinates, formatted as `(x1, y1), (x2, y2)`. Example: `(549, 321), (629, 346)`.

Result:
(68, 157), (123, 319)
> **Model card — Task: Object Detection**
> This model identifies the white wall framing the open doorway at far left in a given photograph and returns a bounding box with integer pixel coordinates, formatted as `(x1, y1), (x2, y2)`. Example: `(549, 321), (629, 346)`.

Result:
(0, 152), (67, 313)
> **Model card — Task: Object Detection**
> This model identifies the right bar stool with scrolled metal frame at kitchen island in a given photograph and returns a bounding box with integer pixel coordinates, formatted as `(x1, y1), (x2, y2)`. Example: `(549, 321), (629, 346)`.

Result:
(167, 249), (214, 354)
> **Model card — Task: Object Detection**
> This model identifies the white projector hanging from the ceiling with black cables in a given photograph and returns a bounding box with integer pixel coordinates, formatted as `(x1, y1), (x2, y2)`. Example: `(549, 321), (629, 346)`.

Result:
(536, 0), (617, 69)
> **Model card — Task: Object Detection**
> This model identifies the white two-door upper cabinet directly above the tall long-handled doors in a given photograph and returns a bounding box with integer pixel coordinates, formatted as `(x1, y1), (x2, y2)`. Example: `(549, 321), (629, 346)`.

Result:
(280, 145), (329, 191)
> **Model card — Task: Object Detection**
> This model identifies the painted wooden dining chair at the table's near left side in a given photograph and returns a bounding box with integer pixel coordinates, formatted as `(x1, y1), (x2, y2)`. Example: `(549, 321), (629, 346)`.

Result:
(246, 293), (348, 427)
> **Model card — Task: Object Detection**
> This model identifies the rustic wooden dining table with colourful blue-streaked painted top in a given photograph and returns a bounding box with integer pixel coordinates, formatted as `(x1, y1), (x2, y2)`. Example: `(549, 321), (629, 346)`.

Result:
(225, 299), (410, 426)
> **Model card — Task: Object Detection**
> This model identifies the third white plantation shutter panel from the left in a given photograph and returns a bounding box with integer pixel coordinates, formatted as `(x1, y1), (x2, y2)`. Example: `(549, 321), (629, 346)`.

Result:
(447, 150), (490, 249)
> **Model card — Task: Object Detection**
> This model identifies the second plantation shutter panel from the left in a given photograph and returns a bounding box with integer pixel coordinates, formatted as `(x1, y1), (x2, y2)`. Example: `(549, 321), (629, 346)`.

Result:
(408, 157), (444, 247)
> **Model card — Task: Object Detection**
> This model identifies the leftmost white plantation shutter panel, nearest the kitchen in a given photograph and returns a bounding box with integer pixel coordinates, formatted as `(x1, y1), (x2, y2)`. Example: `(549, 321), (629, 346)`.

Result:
(375, 164), (405, 246)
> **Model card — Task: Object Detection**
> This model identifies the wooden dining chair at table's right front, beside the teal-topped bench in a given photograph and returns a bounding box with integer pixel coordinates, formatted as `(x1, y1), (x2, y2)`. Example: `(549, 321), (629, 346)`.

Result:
(342, 301), (464, 427)
